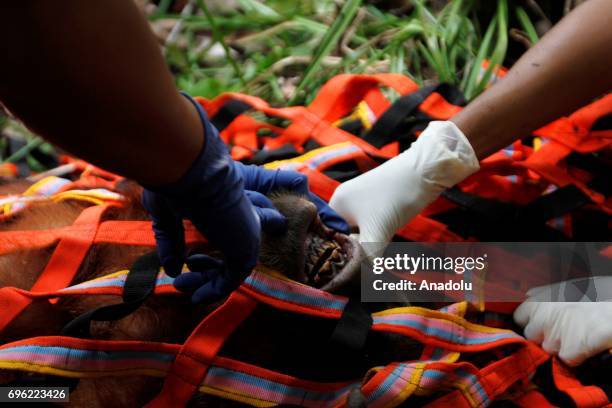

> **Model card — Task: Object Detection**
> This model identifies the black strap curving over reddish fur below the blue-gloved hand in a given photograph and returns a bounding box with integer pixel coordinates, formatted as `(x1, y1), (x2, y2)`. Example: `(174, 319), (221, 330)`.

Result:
(62, 252), (160, 338)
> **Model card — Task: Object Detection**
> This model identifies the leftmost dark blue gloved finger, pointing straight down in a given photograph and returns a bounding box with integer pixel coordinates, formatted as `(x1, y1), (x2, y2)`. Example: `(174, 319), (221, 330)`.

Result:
(142, 190), (185, 277)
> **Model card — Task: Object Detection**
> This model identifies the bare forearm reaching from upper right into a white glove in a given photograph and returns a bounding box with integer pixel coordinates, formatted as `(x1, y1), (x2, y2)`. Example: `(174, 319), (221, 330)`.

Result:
(451, 0), (612, 159)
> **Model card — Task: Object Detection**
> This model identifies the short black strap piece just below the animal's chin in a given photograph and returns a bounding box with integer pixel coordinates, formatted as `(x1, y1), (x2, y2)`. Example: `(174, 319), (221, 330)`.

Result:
(330, 296), (373, 352)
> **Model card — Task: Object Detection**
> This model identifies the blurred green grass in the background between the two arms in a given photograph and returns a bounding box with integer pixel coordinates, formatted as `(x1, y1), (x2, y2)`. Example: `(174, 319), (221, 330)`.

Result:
(161, 0), (537, 105)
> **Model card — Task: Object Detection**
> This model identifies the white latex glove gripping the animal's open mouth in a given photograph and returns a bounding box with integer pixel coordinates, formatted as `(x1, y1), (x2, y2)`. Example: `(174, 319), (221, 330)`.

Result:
(330, 122), (480, 249)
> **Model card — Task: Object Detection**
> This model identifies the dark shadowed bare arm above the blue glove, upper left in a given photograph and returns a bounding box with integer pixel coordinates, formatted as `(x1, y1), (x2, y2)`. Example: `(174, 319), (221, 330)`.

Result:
(0, 0), (203, 185)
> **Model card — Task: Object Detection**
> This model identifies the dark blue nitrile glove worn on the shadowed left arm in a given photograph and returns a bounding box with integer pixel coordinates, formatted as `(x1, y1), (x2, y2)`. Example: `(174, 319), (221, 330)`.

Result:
(143, 95), (268, 302)
